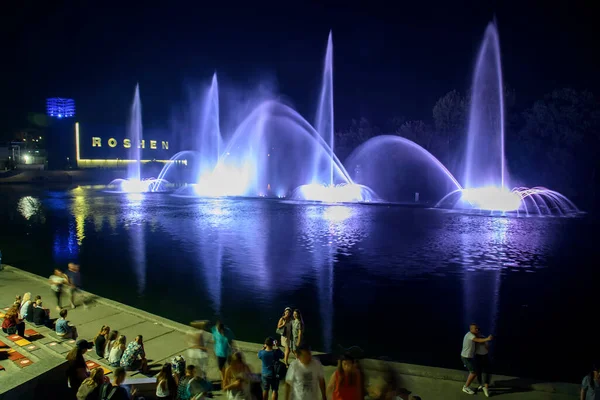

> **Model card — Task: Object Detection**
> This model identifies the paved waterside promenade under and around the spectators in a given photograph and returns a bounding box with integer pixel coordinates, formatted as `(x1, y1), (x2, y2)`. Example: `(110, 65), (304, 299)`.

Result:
(0, 266), (578, 400)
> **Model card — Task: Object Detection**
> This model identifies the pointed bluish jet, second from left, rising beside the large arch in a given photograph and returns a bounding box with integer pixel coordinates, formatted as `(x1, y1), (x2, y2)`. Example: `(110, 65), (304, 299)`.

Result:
(194, 72), (221, 181)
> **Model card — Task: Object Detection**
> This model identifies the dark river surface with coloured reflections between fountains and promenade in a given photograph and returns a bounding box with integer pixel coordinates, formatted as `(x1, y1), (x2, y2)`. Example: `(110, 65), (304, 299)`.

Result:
(0, 185), (600, 382)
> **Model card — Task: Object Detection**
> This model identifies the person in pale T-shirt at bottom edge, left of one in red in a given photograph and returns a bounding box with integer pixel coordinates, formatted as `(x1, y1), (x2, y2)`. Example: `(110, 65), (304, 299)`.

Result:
(285, 345), (327, 400)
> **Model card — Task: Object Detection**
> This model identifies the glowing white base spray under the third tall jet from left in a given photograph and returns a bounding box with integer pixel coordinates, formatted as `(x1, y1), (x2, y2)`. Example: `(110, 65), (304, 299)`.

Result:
(292, 183), (375, 203)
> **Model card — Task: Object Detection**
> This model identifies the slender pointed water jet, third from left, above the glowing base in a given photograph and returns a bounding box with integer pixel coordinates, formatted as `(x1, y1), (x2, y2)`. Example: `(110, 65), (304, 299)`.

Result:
(315, 31), (334, 186)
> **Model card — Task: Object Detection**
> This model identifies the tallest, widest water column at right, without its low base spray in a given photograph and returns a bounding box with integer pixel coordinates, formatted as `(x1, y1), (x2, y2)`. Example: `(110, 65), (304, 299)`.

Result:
(463, 22), (507, 189)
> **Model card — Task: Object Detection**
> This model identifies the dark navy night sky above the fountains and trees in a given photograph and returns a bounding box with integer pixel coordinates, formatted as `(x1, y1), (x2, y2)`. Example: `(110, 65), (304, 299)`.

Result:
(0, 1), (600, 135)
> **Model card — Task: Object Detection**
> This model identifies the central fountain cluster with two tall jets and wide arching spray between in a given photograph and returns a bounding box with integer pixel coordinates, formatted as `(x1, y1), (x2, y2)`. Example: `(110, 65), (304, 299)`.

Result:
(154, 33), (378, 203)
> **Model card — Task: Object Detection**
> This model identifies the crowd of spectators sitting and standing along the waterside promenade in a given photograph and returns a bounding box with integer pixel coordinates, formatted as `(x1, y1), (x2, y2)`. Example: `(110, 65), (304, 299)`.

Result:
(2, 263), (600, 400)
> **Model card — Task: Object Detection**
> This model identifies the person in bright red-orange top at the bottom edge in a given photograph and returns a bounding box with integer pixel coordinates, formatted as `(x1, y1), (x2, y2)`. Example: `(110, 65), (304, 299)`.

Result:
(327, 354), (364, 400)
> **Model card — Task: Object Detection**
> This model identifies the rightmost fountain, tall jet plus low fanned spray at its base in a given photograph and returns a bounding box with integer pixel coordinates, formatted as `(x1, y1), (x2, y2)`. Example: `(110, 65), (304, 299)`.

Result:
(438, 22), (579, 215)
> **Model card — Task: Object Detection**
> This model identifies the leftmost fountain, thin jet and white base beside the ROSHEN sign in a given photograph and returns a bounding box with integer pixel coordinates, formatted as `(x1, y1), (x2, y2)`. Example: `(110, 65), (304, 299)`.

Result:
(108, 84), (165, 193)
